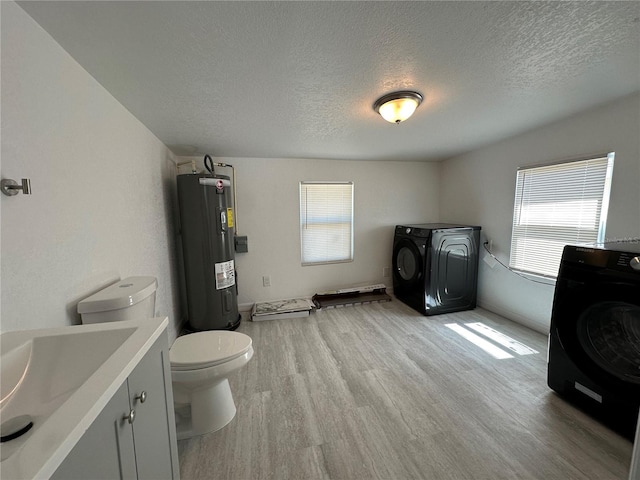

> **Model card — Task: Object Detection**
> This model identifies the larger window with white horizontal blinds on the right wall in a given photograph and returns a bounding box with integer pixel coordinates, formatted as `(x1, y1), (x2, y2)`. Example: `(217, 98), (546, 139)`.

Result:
(509, 153), (614, 278)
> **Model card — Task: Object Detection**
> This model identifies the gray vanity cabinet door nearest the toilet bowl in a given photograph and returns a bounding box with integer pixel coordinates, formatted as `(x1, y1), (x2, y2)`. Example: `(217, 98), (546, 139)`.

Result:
(129, 336), (179, 480)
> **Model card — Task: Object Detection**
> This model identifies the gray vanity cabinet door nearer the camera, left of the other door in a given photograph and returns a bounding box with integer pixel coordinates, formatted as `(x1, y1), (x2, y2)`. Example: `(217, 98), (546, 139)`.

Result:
(51, 382), (136, 480)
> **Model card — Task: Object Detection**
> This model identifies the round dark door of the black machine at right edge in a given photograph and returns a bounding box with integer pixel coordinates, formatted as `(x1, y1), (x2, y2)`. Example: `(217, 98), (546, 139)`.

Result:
(554, 280), (640, 396)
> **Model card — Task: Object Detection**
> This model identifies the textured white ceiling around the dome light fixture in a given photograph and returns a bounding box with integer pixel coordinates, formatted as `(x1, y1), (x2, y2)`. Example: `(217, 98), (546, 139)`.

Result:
(19, 1), (640, 160)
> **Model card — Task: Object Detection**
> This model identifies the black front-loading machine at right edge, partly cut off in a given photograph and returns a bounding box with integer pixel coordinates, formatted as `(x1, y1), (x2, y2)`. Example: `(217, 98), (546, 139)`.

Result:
(548, 244), (640, 439)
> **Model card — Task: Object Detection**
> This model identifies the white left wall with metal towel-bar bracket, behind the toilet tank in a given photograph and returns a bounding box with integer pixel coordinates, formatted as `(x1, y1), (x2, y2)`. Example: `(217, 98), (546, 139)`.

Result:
(0, 2), (179, 342)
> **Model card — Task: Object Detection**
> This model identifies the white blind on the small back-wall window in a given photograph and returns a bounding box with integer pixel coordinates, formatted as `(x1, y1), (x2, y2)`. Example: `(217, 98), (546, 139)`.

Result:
(300, 182), (353, 265)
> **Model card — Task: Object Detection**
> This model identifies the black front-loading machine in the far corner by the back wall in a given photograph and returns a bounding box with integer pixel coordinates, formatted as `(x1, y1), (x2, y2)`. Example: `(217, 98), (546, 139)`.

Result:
(392, 223), (480, 315)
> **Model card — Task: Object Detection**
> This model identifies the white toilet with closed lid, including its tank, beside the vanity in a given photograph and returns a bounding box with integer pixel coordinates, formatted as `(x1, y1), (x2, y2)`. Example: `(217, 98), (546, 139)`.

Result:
(78, 277), (253, 440)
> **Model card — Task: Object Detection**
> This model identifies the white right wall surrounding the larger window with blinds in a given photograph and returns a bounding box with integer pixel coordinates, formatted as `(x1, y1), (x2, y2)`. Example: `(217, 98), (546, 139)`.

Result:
(440, 93), (640, 332)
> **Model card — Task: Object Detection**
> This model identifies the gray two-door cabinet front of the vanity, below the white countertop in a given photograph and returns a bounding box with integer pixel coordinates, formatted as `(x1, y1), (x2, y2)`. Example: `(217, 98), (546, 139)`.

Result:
(51, 333), (179, 480)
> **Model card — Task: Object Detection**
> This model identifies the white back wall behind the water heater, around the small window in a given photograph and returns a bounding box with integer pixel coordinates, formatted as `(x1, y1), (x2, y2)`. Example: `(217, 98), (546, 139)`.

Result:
(174, 157), (439, 308)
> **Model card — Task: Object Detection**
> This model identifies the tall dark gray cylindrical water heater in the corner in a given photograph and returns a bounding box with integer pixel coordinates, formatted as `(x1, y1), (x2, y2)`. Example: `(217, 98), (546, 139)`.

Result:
(177, 174), (240, 330)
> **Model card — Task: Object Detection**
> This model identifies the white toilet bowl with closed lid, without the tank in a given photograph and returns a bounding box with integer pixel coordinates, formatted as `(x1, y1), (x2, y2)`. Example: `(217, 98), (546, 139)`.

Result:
(169, 330), (253, 440)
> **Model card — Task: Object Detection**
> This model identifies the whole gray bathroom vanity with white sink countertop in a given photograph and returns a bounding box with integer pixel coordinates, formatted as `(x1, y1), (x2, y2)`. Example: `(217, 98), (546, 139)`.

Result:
(0, 318), (180, 480)
